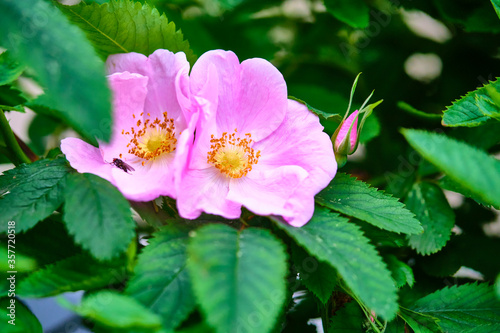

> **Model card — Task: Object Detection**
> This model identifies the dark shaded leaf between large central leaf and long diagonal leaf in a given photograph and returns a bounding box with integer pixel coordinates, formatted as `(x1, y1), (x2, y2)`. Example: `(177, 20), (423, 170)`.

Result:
(292, 246), (338, 304)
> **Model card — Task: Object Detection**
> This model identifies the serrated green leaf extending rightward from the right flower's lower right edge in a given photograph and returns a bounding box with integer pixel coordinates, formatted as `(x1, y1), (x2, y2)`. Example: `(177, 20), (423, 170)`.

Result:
(316, 173), (422, 234)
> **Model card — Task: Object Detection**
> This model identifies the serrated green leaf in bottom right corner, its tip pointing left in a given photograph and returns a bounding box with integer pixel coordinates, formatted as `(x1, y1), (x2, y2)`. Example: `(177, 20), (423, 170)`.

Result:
(411, 283), (500, 332)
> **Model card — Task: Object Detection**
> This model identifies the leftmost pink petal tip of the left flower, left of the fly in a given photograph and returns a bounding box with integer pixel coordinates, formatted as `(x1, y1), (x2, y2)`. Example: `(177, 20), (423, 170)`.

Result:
(61, 138), (114, 183)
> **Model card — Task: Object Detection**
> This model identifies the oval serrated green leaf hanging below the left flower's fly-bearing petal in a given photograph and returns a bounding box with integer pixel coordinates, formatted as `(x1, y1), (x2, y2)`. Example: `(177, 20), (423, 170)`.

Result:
(63, 173), (135, 259)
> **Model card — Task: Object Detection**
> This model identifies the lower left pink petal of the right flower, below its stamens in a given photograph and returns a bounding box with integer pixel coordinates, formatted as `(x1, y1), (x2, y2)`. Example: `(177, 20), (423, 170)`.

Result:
(177, 167), (241, 219)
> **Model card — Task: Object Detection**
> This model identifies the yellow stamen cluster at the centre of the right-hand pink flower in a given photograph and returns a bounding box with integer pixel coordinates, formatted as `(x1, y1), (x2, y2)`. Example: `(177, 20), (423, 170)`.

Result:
(207, 129), (260, 178)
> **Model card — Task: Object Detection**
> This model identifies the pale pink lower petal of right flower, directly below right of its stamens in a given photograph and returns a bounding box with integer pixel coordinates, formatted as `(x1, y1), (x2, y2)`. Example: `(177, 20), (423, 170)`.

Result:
(227, 165), (308, 215)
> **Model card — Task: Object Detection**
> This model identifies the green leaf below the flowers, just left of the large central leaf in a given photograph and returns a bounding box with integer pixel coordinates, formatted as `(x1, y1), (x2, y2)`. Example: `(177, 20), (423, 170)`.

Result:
(126, 225), (195, 329)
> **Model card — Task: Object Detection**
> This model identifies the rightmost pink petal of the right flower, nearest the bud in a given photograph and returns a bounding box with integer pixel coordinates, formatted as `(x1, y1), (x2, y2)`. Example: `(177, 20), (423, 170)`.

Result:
(254, 100), (337, 226)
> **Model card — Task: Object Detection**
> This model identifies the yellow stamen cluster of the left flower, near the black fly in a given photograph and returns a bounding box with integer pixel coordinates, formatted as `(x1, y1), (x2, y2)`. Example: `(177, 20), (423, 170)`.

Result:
(122, 112), (177, 165)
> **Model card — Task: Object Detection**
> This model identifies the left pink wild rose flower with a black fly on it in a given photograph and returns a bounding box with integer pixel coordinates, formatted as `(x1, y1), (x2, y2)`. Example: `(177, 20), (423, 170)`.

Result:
(61, 50), (198, 201)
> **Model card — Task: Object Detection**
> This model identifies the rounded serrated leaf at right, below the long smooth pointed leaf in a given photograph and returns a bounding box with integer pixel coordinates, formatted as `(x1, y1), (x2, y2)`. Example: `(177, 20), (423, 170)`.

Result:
(405, 182), (455, 255)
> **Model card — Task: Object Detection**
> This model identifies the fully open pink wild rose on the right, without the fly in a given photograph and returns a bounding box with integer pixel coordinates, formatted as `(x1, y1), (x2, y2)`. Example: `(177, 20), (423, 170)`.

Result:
(177, 50), (337, 227)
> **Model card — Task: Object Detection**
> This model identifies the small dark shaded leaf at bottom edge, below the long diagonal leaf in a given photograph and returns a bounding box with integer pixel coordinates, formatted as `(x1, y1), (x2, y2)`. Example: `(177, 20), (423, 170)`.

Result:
(328, 301), (366, 333)
